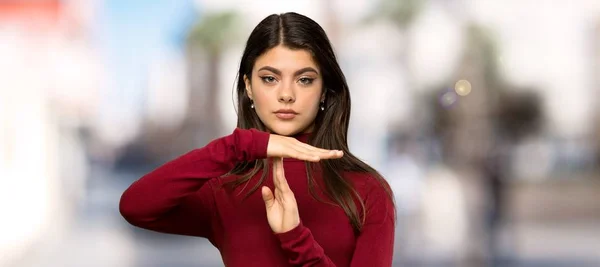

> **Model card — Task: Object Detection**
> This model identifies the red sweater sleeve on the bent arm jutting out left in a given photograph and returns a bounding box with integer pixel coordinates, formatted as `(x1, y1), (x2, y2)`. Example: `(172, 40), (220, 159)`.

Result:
(119, 128), (269, 238)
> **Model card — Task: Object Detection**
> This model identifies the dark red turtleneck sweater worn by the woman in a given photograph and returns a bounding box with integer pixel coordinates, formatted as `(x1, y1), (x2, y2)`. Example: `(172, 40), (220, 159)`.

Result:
(119, 129), (394, 267)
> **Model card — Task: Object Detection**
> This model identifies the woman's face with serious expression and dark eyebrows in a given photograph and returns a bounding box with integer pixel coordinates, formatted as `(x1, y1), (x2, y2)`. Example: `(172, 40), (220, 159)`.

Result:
(244, 45), (325, 136)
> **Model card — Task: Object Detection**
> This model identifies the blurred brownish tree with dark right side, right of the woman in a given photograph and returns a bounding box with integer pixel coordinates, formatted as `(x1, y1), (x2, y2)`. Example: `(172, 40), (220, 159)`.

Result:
(427, 24), (542, 168)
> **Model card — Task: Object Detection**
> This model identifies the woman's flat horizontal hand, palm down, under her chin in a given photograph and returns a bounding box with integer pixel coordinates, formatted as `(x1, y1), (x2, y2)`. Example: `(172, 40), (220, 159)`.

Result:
(267, 134), (344, 162)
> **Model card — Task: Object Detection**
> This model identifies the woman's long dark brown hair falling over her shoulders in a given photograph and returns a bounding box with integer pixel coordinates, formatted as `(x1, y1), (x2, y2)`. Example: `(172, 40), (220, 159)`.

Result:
(227, 12), (394, 232)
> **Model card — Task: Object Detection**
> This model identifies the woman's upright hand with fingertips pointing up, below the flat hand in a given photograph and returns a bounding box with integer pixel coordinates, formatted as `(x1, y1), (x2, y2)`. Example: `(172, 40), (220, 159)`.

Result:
(262, 158), (300, 234)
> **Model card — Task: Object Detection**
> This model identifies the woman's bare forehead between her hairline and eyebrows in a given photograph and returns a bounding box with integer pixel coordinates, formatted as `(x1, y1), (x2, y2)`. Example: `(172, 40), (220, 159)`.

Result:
(254, 45), (319, 72)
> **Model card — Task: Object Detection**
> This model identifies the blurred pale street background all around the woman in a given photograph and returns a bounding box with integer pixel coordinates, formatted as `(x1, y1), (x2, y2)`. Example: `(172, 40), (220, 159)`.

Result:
(0, 0), (600, 267)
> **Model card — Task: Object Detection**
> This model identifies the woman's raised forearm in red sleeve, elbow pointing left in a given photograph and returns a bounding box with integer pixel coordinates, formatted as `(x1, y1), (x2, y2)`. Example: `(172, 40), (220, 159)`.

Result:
(119, 129), (269, 224)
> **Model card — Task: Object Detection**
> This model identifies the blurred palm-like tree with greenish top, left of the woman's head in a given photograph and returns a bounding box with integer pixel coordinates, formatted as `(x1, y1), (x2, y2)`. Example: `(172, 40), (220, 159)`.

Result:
(133, 11), (240, 164)
